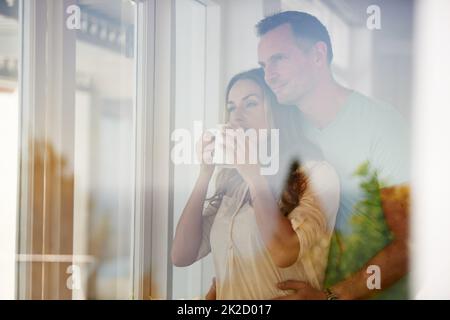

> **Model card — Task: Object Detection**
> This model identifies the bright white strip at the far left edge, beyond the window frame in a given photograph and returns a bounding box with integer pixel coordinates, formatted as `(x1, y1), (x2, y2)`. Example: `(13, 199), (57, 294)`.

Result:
(0, 10), (19, 299)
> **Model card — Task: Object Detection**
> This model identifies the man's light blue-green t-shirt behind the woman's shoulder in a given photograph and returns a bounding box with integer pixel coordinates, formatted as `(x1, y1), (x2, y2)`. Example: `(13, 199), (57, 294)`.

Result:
(300, 92), (409, 233)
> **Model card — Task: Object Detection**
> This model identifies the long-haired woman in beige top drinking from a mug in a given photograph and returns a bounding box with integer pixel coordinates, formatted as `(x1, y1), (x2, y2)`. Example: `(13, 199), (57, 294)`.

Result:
(172, 69), (339, 299)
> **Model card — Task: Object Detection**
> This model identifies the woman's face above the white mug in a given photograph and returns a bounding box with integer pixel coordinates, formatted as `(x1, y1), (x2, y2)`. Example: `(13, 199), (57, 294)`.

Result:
(227, 80), (268, 130)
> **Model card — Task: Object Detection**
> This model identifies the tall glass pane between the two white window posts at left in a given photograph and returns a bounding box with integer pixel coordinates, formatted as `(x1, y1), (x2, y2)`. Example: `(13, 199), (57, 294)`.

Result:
(73, 0), (135, 299)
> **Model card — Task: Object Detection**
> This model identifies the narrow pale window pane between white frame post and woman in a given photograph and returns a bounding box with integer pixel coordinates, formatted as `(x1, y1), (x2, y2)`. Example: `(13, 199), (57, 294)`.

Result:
(173, 0), (206, 299)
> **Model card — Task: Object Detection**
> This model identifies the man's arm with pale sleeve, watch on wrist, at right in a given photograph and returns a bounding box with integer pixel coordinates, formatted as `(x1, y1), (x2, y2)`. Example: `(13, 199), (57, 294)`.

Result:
(332, 106), (410, 299)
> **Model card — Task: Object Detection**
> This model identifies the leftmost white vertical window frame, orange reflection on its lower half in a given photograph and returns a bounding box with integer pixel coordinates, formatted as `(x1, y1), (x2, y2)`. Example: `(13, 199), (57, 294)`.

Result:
(16, 0), (75, 299)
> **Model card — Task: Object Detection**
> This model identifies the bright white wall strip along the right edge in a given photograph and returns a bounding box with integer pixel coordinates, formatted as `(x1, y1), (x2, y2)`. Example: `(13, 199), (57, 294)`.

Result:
(412, 0), (450, 299)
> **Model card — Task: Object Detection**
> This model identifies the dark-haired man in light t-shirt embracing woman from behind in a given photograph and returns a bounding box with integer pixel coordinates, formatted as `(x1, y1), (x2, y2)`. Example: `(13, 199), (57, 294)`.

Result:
(257, 11), (409, 299)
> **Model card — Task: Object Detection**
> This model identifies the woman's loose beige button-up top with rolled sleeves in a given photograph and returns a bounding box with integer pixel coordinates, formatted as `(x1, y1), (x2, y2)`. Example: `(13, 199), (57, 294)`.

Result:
(197, 162), (340, 299)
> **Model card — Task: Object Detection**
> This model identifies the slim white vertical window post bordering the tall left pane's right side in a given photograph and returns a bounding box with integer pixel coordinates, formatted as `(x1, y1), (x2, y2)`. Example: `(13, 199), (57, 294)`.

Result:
(131, 0), (156, 299)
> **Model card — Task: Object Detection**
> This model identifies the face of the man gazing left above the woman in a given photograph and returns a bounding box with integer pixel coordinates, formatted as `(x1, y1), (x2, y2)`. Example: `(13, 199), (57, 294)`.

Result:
(258, 23), (316, 106)
